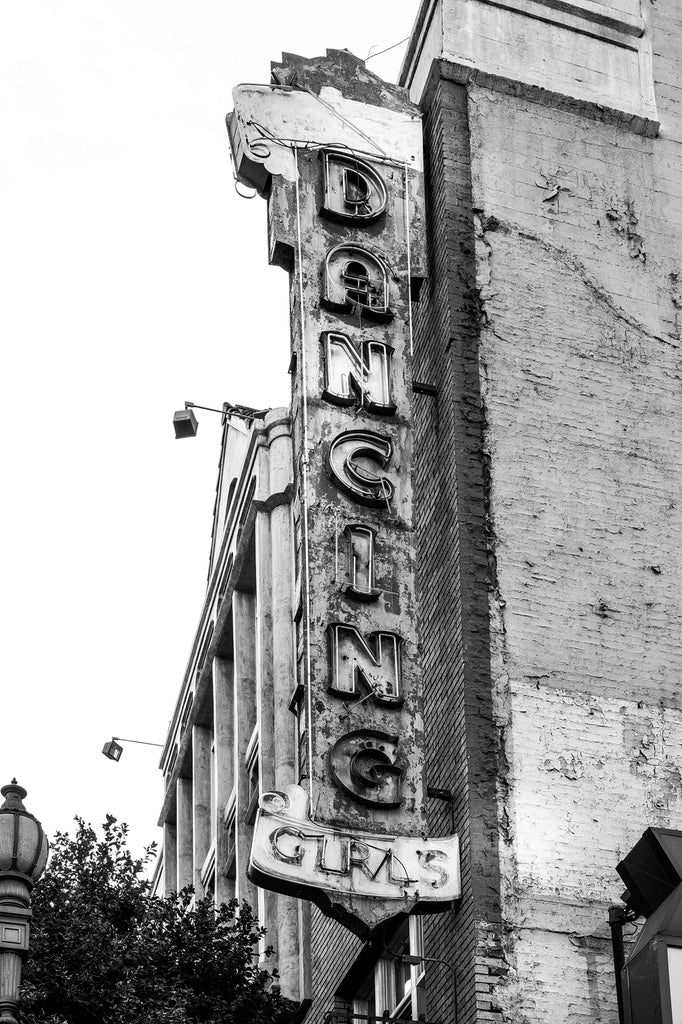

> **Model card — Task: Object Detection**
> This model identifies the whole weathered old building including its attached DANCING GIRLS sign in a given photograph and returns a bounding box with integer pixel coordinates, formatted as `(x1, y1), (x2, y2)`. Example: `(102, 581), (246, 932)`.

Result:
(156, 0), (682, 1024)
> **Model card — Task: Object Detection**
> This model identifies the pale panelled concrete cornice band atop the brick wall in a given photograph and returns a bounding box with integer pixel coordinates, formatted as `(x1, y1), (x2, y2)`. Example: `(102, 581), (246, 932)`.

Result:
(400, 0), (659, 135)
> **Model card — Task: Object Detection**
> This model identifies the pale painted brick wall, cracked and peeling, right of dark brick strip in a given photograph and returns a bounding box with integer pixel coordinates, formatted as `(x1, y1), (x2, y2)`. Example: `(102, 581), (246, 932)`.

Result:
(458, 0), (682, 1024)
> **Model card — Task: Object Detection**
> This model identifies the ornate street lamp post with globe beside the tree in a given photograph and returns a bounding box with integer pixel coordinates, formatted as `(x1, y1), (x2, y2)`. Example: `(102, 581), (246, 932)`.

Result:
(0, 778), (49, 1024)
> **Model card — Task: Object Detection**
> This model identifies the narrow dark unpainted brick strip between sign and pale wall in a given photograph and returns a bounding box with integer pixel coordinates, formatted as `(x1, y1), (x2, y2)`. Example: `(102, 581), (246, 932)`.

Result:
(415, 82), (502, 1024)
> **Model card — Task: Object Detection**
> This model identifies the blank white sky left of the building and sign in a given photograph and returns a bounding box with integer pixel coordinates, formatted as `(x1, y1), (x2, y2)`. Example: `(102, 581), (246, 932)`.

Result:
(0, 0), (418, 852)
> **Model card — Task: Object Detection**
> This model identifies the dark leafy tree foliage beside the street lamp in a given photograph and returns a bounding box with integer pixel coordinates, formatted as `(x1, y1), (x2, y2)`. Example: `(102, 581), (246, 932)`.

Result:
(20, 816), (289, 1024)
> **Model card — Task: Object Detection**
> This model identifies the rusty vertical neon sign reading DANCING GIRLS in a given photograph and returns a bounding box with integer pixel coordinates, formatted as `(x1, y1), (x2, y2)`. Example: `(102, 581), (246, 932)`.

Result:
(228, 58), (460, 933)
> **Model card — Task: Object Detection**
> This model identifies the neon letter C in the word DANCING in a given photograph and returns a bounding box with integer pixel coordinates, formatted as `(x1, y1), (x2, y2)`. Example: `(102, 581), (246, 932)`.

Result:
(327, 430), (395, 508)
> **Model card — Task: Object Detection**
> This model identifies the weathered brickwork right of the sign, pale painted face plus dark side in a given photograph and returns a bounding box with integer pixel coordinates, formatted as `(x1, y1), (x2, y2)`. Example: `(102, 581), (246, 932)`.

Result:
(299, 0), (682, 1024)
